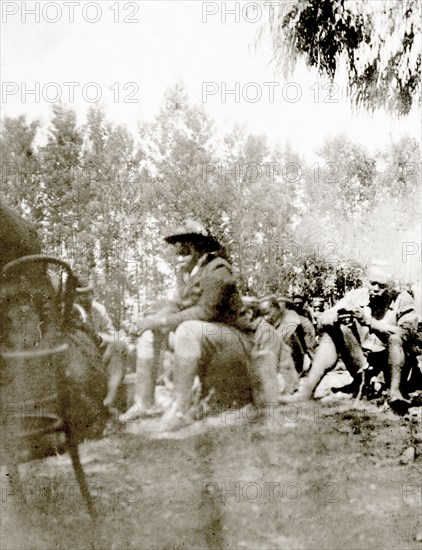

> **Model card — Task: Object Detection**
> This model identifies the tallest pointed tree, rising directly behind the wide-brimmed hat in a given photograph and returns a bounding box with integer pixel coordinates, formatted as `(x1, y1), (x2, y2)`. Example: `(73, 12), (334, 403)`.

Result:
(131, 82), (225, 312)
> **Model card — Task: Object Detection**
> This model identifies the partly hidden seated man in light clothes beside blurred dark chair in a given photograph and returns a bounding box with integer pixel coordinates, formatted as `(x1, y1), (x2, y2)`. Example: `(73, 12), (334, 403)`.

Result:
(75, 282), (128, 410)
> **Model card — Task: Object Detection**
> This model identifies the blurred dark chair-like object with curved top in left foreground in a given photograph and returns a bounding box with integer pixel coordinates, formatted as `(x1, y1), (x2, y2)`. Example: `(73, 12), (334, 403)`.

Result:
(0, 204), (99, 516)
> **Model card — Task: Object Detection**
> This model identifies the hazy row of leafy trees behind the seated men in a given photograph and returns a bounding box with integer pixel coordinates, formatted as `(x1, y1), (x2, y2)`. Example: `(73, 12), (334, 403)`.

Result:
(1, 83), (420, 327)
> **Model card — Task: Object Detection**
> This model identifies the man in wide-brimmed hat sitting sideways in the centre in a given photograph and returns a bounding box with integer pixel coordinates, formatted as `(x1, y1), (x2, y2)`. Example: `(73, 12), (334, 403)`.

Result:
(120, 220), (275, 431)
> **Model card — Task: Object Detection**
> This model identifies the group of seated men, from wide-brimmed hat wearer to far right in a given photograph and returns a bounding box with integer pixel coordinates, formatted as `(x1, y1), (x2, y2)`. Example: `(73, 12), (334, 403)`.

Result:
(84, 220), (419, 431)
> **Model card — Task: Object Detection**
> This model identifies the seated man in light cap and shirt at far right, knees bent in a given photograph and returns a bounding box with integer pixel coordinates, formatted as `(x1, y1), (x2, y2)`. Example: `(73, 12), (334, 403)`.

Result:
(280, 262), (418, 411)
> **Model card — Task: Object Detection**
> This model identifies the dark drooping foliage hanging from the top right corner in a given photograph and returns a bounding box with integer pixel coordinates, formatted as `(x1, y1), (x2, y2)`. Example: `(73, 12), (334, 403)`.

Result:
(258, 0), (421, 115)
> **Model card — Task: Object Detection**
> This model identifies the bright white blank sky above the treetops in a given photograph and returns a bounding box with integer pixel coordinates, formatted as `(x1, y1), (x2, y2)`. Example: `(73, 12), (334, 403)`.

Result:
(1, 0), (420, 156)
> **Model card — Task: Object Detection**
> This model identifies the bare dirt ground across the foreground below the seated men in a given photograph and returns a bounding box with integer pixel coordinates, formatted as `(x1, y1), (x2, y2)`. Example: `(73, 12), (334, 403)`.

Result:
(1, 374), (422, 550)
